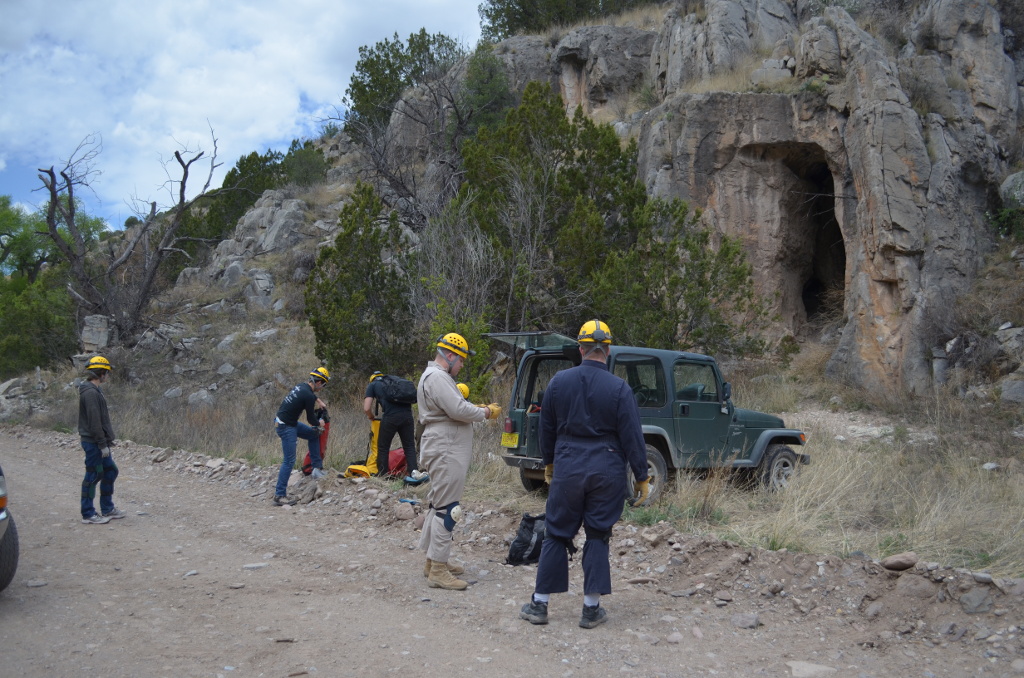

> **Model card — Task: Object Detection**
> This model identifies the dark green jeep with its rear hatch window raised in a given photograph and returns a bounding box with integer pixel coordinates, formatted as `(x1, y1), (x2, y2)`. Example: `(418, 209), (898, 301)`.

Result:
(484, 332), (810, 504)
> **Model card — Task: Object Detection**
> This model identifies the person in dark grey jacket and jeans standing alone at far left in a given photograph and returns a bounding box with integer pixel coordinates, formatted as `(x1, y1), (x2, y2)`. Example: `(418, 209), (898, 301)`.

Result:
(78, 355), (127, 525)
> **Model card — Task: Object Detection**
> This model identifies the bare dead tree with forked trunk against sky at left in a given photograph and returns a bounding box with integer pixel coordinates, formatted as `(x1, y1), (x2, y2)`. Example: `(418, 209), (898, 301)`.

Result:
(39, 128), (219, 341)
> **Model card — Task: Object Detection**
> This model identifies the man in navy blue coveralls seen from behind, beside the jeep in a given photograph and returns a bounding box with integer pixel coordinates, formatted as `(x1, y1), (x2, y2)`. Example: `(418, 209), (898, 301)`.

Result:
(519, 321), (649, 629)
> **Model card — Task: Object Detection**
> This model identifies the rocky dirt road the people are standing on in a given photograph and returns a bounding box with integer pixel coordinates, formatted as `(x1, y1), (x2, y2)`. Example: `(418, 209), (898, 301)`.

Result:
(0, 427), (1024, 678)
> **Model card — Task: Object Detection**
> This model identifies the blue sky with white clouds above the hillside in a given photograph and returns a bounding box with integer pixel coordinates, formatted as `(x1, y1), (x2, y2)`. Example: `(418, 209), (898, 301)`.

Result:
(0, 0), (480, 227)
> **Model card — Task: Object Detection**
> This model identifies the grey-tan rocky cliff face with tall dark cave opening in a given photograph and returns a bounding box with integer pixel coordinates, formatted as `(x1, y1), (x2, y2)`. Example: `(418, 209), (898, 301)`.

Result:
(485, 0), (1024, 392)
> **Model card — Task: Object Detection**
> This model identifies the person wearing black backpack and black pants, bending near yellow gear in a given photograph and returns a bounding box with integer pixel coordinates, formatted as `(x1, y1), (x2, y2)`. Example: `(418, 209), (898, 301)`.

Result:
(362, 372), (418, 477)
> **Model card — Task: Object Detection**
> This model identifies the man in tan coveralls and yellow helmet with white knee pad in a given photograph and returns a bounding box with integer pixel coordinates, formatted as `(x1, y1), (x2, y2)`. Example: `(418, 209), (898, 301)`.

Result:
(417, 332), (502, 591)
